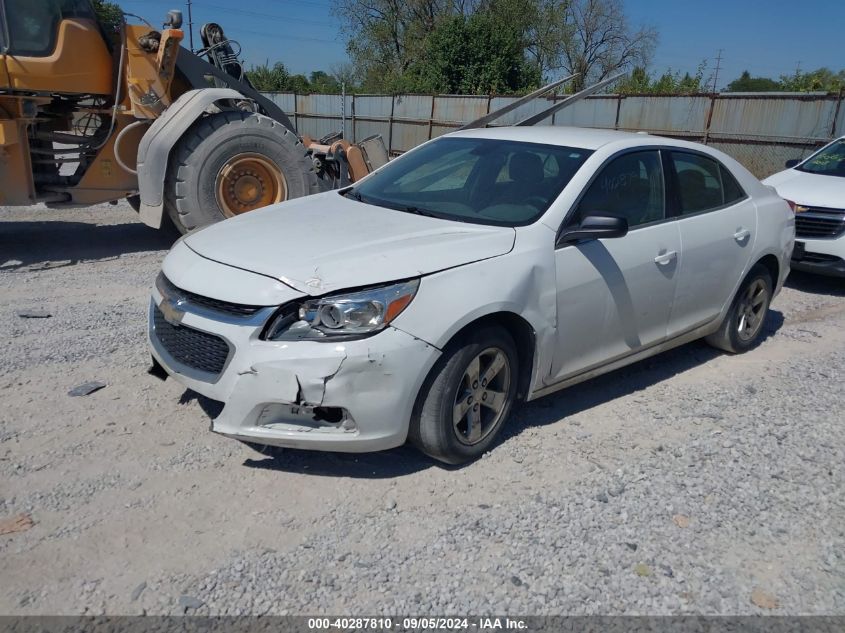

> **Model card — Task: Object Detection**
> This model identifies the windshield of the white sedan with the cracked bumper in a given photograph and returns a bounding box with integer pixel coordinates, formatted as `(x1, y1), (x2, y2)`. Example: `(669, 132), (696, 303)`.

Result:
(344, 137), (592, 226)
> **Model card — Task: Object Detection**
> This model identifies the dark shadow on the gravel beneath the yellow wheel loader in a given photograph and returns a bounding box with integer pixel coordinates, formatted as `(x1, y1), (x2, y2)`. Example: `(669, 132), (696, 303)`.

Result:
(0, 221), (175, 271)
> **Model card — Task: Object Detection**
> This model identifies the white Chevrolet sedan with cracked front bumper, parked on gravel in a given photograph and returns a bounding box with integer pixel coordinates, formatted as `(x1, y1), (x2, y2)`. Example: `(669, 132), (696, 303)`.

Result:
(149, 127), (795, 463)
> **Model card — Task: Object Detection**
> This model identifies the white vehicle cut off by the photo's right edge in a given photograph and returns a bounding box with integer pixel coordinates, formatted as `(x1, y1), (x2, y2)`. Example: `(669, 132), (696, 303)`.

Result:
(763, 137), (845, 277)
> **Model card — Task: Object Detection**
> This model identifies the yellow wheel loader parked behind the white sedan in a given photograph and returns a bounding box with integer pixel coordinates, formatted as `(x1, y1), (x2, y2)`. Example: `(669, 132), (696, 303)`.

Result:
(0, 0), (387, 233)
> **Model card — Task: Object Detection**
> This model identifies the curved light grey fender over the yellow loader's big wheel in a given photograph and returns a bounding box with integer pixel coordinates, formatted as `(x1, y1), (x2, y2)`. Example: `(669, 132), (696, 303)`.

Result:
(138, 88), (252, 229)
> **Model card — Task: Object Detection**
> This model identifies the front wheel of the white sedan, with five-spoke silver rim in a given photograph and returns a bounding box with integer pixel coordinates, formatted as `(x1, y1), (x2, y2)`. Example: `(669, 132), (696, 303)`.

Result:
(408, 327), (519, 464)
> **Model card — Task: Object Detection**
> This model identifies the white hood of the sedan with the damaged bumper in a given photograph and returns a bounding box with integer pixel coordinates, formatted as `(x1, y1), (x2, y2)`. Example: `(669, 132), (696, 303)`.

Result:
(184, 191), (516, 296)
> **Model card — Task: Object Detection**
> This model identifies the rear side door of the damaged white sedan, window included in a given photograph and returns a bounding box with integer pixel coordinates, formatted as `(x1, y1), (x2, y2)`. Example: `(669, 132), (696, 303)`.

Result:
(668, 150), (757, 336)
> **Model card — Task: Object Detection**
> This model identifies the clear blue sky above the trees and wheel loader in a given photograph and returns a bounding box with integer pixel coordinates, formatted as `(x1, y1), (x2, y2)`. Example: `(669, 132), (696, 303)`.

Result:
(125, 0), (845, 88)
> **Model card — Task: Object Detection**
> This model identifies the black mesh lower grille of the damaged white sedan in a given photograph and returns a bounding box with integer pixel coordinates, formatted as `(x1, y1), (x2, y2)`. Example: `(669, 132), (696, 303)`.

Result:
(153, 306), (229, 376)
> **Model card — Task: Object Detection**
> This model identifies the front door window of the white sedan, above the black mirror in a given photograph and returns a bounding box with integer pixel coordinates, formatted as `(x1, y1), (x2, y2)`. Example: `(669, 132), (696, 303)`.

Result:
(569, 150), (666, 228)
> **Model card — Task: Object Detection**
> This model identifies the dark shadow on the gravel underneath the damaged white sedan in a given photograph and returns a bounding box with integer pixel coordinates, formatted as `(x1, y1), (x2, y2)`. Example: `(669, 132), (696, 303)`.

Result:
(180, 310), (784, 479)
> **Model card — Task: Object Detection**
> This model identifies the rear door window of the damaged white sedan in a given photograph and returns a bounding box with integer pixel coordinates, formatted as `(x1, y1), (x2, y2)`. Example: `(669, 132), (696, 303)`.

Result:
(671, 152), (745, 215)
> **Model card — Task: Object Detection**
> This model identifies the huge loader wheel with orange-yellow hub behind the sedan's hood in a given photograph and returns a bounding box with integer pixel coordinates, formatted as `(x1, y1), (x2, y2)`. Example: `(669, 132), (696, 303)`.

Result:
(165, 111), (323, 233)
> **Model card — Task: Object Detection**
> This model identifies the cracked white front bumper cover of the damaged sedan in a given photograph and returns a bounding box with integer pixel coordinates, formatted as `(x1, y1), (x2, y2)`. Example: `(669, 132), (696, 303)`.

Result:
(148, 291), (440, 452)
